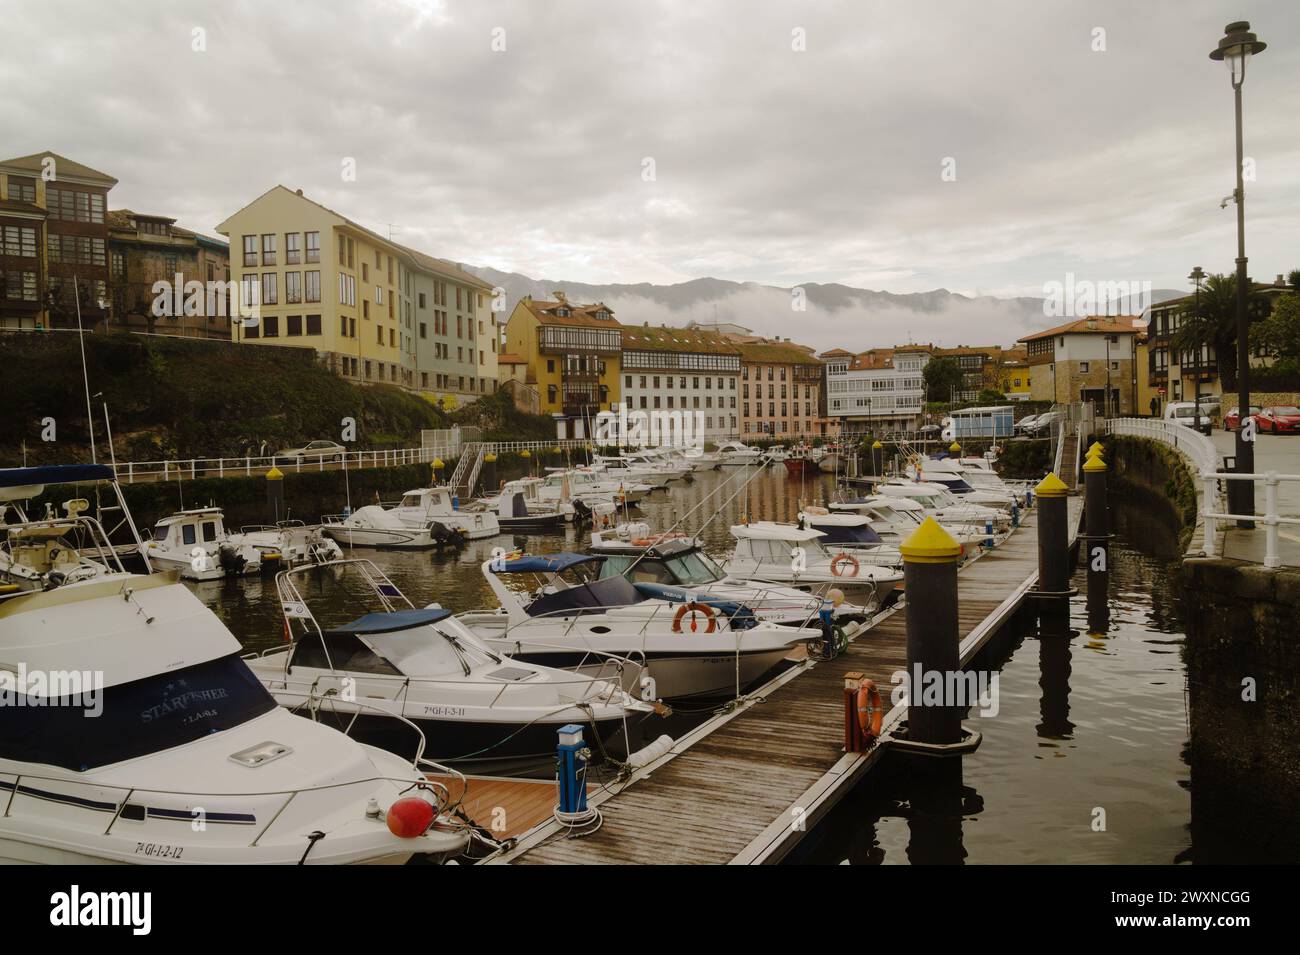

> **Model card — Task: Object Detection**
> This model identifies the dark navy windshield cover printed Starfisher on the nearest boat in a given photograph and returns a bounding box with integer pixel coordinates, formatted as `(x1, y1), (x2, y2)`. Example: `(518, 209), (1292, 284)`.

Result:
(0, 654), (276, 772)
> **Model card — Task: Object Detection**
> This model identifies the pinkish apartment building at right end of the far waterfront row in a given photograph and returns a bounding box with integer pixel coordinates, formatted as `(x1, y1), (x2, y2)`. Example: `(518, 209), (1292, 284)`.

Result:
(736, 339), (829, 442)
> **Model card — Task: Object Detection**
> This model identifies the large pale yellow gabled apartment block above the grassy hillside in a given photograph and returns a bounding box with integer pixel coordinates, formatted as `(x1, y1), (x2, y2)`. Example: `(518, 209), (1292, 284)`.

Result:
(217, 186), (497, 403)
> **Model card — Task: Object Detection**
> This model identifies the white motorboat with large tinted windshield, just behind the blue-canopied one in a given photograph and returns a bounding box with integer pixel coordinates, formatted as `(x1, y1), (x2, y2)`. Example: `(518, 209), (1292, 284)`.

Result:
(590, 524), (875, 630)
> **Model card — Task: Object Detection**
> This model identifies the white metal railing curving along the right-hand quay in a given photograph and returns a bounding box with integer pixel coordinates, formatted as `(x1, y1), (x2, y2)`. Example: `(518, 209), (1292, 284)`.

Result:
(1106, 418), (1300, 567)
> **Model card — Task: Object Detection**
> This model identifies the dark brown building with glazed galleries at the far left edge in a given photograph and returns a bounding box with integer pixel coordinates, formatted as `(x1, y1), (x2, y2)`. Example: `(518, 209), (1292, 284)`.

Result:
(0, 152), (117, 330)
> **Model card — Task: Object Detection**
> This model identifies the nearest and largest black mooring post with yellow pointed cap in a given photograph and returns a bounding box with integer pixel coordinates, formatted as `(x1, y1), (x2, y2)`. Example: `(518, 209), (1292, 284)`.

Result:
(898, 517), (962, 745)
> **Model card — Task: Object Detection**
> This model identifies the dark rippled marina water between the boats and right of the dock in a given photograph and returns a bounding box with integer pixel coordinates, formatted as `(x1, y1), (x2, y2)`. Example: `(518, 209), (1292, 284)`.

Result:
(183, 468), (1245, 864)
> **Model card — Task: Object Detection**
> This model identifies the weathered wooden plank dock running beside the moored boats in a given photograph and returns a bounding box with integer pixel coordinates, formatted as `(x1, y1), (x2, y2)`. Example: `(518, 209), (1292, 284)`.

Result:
(486, 498), (1083, 865)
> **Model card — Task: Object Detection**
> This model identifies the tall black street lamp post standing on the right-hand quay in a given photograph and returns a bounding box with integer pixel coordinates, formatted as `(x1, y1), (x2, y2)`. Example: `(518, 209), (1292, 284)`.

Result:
(1210, 19), (1268, 528)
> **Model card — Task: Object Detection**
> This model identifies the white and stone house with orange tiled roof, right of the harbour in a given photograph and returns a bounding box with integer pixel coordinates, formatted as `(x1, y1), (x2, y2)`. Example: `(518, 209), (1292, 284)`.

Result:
(1019, 316), (1141, 414)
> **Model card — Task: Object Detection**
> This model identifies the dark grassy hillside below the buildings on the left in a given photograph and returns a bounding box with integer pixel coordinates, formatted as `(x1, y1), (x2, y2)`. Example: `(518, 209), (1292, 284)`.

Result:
(0, 333), (449, 466)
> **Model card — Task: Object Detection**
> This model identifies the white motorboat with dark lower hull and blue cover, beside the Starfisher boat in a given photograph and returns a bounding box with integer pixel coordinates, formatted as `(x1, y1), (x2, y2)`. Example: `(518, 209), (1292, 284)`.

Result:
(246, 559), (654, 773)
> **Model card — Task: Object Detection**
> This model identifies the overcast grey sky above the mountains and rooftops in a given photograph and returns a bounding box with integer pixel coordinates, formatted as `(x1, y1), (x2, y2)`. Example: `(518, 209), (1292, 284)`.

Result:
(0, 0), (1300, 311)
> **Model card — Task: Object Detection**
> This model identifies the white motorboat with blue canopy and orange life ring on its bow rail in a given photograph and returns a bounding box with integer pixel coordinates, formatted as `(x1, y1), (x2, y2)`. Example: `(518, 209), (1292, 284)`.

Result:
(458, 554), (823, 699)
